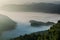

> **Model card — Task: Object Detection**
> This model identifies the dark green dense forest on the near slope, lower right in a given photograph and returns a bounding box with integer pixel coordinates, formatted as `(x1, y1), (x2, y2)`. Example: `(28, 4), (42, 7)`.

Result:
(11, 20), (60, 40)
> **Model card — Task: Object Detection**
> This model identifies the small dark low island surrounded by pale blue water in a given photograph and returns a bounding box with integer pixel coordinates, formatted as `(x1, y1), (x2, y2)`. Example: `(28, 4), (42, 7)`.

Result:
(29, 20), (55, 27)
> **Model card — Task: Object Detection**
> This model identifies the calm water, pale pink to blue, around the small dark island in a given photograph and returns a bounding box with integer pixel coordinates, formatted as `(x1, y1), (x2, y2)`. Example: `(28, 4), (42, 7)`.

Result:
(0, 11), (60, 39)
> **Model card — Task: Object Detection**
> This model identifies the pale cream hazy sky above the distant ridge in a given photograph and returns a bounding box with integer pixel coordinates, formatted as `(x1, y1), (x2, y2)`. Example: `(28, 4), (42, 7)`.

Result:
(0, 0), (60, 6)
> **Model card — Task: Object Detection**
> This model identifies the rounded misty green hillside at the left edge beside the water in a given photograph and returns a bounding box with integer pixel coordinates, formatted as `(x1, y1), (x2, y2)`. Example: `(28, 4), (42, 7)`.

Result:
(0, 14), (16, 33)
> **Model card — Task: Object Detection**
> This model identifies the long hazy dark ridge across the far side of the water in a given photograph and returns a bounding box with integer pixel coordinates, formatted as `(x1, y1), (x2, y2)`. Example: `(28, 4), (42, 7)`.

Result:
(1, 3), (60, 13)
